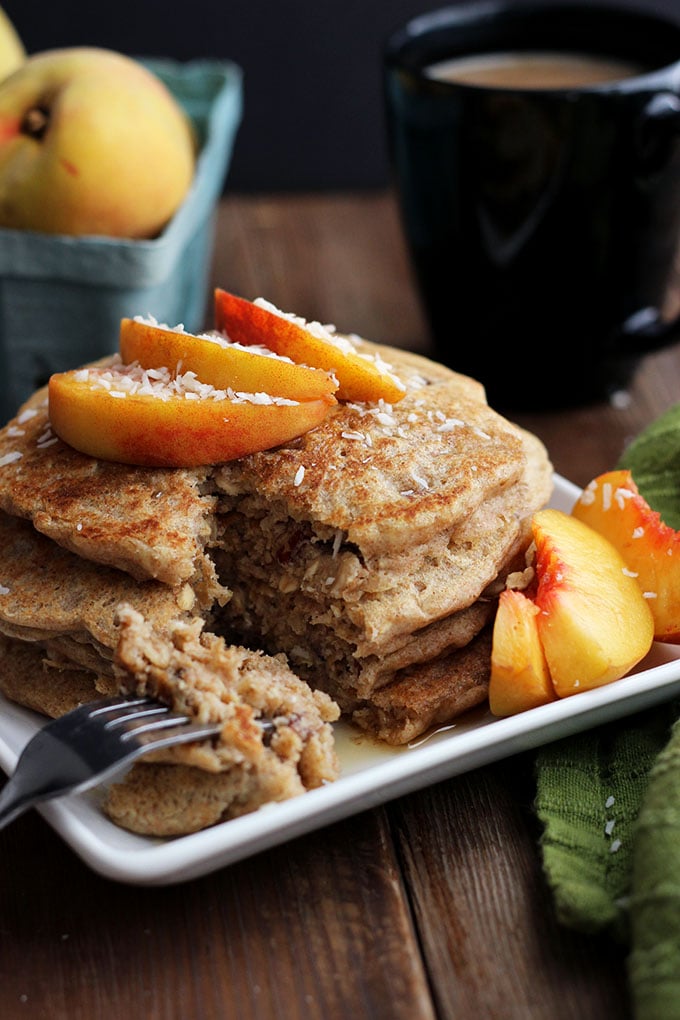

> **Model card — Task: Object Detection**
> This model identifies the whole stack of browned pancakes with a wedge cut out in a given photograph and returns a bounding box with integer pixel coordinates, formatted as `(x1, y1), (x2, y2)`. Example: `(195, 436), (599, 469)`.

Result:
(0, 338), (552, 824)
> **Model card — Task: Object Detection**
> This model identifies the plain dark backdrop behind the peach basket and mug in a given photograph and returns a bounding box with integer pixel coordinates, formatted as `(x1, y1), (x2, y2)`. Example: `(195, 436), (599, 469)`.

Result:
(0, 0), (680, 191)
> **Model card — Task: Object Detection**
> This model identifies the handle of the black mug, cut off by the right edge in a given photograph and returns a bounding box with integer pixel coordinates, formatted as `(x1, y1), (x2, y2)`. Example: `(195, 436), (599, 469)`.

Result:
(617, 92), (680, 355)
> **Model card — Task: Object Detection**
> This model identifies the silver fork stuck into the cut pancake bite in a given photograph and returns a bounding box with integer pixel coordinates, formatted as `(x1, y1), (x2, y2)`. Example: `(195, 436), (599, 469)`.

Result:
(0, 697), (223, 828)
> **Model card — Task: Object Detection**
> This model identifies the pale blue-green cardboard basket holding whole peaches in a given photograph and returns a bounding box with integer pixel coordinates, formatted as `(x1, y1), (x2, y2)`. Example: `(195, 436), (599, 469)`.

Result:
(0, 59), (243, 424)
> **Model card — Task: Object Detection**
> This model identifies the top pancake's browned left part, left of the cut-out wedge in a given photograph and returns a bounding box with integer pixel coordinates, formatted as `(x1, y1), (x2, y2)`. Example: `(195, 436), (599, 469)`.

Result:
(0, 381), (217, 603)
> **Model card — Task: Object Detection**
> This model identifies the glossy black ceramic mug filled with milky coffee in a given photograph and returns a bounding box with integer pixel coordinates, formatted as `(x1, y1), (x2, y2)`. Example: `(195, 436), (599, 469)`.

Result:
(384, 0), (680, 409)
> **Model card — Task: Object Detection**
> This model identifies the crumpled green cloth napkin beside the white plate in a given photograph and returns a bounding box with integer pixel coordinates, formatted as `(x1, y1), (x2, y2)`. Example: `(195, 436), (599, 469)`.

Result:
(535, 404), (680, 1020)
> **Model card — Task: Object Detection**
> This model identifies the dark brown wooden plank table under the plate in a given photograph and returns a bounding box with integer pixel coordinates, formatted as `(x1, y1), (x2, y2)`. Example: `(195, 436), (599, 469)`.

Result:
(0, 194), (680, 1020)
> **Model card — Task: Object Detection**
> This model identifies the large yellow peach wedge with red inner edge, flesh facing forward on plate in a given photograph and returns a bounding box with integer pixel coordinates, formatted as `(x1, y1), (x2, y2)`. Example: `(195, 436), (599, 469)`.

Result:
(532, 509), (653, 698)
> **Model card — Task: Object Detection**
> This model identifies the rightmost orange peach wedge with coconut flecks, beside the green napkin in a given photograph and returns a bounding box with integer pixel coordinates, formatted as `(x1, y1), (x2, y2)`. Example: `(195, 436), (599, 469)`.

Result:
(572, 469), (680, 645)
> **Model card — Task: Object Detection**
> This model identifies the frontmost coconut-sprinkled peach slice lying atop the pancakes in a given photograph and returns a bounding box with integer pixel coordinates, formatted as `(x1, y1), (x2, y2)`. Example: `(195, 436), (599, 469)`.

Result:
(49, 365), (335, 467)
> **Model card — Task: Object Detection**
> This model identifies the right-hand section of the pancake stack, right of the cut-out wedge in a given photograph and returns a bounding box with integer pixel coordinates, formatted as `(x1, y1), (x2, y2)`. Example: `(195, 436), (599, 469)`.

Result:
(214, 344), (553, 734)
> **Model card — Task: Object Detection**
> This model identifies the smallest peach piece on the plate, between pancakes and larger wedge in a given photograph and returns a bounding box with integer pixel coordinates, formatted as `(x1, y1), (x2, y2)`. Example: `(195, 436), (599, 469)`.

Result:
(488, 589), (557, 716)
